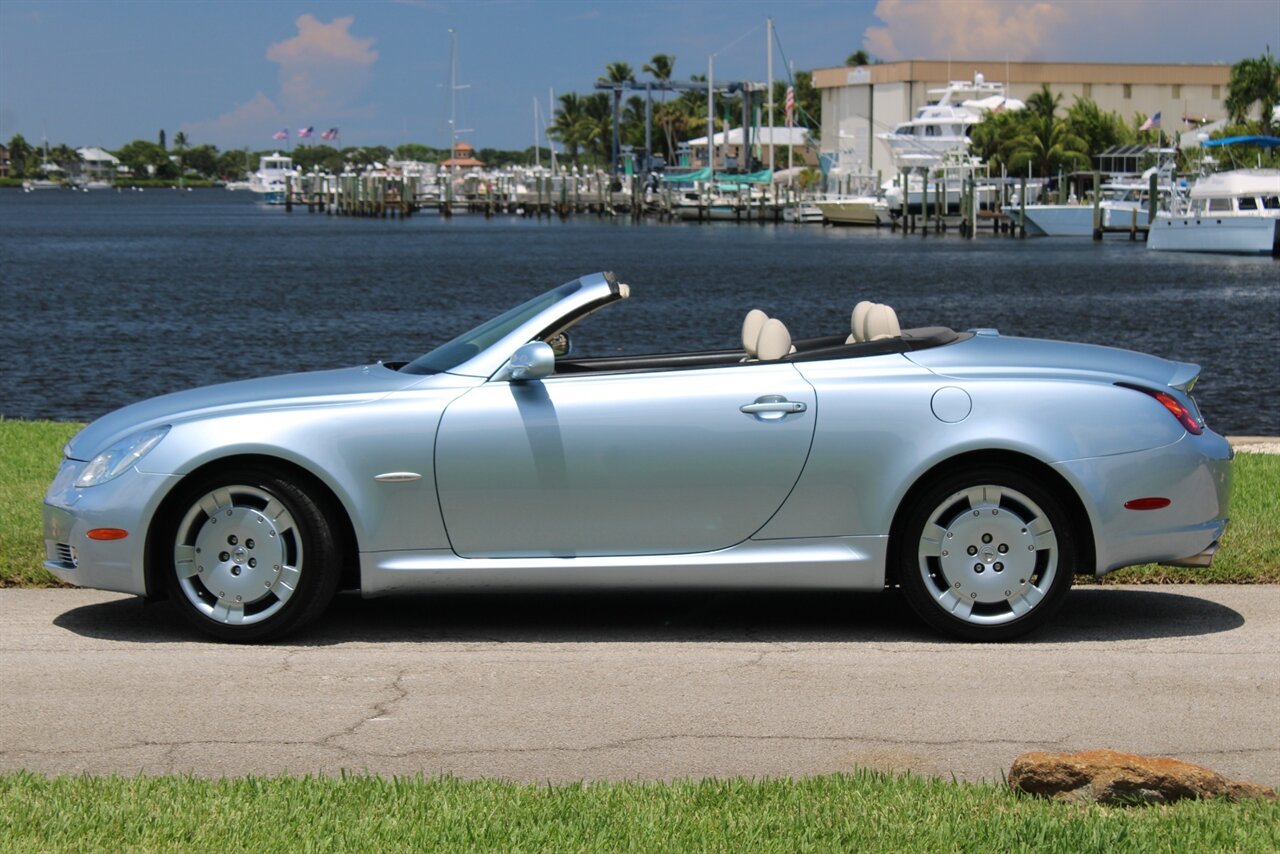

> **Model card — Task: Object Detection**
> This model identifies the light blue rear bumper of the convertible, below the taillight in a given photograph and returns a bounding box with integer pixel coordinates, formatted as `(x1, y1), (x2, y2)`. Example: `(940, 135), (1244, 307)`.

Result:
(1055, 430), (1234, 576)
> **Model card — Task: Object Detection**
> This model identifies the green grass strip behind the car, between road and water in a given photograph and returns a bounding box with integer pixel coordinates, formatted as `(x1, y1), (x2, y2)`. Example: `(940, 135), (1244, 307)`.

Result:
(0, 419), (1280, 586)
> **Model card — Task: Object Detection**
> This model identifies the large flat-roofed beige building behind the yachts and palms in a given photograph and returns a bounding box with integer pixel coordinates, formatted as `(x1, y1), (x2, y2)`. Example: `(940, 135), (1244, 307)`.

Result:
(813, 60), (1231, 175)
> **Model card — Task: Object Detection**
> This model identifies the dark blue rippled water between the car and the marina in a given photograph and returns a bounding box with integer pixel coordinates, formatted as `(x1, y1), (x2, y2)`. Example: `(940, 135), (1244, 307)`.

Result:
(0, 191), (1280, 434)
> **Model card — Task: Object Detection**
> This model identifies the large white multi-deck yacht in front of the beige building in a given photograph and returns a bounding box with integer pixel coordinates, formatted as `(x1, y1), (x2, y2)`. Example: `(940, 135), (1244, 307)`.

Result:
(877, 74), (1027, 169)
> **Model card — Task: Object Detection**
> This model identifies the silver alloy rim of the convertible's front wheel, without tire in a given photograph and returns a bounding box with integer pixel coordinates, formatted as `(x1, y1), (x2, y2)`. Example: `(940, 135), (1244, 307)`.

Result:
(173, 484), (302, 625)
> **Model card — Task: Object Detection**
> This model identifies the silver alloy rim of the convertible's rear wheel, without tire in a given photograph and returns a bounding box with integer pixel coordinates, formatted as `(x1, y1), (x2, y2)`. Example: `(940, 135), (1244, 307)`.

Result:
(916, 484), (1060, 626)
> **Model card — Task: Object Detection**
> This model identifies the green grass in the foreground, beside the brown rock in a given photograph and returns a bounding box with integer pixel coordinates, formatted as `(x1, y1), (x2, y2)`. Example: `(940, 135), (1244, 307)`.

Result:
(0, 771), (1280, 854)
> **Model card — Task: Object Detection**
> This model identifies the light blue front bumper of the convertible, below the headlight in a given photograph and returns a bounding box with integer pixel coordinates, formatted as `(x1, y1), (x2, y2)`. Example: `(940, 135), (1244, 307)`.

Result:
(44, 460), (178, 595)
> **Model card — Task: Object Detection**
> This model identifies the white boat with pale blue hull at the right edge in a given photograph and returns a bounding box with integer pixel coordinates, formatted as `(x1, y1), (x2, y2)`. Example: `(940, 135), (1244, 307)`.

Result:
(1147, 169), (1280, 255)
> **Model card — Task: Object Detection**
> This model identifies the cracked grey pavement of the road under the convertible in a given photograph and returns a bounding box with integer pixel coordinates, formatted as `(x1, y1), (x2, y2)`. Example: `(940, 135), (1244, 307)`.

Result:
(0, 585), (1280, 786)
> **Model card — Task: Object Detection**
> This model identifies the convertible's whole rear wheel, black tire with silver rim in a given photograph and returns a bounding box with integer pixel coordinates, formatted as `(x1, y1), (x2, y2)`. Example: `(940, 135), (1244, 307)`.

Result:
(895, 466), (1078, 641)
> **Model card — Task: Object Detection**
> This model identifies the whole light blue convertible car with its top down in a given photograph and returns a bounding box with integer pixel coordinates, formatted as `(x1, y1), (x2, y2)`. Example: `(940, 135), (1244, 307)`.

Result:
(45, 274), (1231, 640)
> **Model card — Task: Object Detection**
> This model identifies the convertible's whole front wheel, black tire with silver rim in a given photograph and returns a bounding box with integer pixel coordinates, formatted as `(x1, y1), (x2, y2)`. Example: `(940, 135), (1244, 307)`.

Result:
(157, 467), (342, 643)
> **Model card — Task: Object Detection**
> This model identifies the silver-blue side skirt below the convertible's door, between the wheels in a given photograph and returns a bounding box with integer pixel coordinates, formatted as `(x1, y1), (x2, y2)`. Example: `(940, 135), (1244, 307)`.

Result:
(360, 536), (888, 597)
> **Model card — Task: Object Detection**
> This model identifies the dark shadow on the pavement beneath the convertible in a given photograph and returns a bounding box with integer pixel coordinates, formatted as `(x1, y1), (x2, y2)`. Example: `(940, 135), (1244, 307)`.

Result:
(54, 586), (1244, 647)
